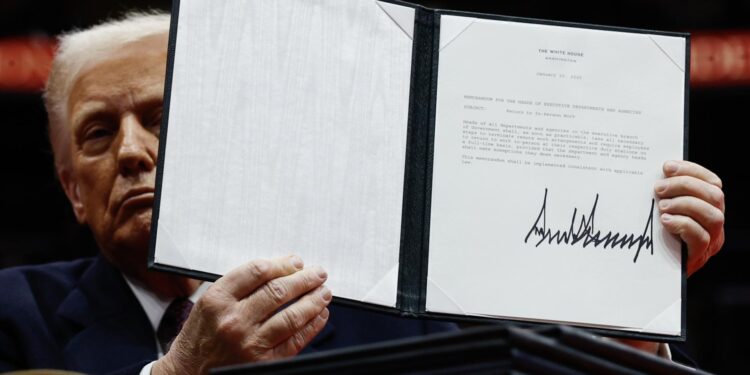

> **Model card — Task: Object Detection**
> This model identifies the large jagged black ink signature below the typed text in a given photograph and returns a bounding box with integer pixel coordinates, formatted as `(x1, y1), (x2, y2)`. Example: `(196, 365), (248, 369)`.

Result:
(523, 188), (654, 263)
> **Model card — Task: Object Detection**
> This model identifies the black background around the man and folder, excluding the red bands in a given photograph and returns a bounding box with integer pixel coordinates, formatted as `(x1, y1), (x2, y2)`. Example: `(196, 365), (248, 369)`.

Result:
(0, 0), (750, 373)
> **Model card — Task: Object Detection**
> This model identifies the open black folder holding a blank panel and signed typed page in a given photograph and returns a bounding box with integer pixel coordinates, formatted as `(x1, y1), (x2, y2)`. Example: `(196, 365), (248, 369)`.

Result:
(150, 0), (689, 340)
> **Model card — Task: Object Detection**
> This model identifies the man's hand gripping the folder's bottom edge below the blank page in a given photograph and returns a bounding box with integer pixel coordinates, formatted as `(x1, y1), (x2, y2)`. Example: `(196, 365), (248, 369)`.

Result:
(152, 256), (331, 374)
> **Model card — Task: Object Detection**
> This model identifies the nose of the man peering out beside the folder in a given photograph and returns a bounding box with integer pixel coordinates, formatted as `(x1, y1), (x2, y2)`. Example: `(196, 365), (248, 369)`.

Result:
(117, 114), (156, 176)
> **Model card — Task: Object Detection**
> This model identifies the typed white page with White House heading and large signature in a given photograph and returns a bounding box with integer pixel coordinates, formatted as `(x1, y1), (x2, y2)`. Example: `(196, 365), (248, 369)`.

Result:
(427, 16), (685, 335)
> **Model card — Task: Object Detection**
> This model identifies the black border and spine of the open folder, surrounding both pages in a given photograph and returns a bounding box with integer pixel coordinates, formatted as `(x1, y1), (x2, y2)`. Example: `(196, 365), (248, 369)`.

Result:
(148, 0), (690, 342)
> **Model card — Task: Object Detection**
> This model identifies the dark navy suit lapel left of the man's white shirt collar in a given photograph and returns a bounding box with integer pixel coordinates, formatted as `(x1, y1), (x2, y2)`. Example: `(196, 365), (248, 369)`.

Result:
(57, 256), (156, 373)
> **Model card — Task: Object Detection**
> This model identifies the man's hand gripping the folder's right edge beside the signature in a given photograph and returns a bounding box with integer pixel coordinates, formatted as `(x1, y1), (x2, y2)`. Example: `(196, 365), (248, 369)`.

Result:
(654, 161), (724, 275)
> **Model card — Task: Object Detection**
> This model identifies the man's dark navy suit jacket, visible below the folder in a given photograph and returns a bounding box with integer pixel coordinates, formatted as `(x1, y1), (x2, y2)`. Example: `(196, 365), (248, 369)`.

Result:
(0, 256), (456, 374)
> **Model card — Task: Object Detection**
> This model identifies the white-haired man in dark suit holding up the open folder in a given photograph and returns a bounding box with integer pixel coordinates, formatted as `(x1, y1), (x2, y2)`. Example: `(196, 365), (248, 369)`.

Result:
(0, 11), (724, 374)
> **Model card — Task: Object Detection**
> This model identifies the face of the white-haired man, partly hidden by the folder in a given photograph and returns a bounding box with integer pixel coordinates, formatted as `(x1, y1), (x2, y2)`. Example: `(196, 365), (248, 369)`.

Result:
(61, 35), (167, 272)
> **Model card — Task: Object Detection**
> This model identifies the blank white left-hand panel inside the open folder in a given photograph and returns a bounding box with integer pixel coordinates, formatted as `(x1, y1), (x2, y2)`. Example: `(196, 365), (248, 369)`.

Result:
(155, 0), (414, 306)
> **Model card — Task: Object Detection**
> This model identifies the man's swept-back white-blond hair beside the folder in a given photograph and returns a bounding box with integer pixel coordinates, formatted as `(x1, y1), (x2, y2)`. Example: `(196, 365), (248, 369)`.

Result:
(44, 12), (169, 173)
